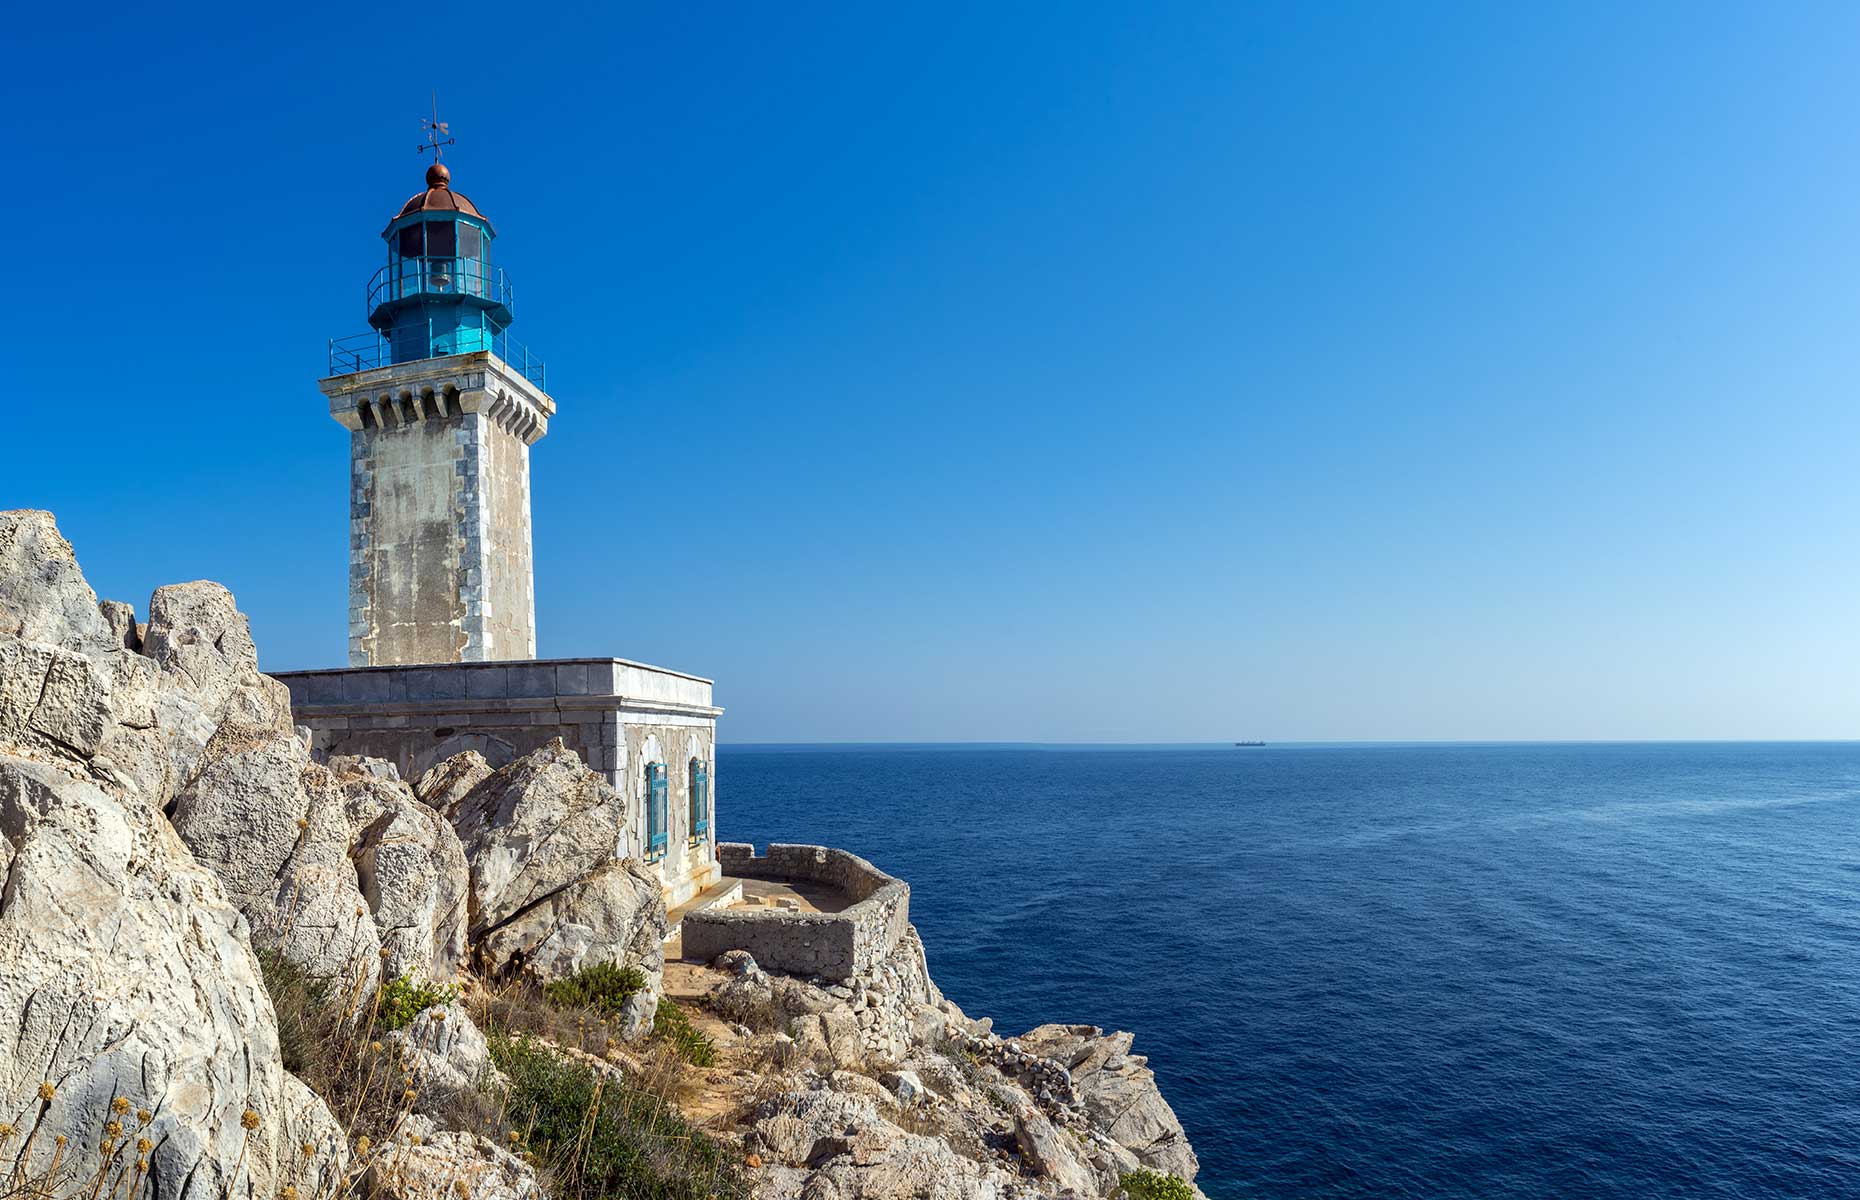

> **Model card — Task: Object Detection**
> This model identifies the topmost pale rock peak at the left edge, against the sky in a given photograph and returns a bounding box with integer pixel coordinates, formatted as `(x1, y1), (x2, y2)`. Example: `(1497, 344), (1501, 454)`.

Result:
(0, 508), (121, 653)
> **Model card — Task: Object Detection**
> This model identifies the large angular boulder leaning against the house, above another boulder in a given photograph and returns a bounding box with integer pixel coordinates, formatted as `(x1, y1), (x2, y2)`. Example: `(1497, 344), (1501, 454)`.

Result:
(452, 739), (625, 938)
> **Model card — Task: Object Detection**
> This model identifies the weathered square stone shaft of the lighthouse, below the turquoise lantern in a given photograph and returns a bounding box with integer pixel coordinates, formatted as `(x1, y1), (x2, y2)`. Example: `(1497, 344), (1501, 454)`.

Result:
(322, 352), (554, 666)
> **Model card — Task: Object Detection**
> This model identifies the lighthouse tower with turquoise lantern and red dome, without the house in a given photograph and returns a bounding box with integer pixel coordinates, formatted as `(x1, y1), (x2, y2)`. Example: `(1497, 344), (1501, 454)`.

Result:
(318, 162), (556, 666)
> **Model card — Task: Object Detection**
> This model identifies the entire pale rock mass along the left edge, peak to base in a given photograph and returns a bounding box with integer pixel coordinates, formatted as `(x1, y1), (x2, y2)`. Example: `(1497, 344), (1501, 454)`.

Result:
(0, 512), (344, 1200)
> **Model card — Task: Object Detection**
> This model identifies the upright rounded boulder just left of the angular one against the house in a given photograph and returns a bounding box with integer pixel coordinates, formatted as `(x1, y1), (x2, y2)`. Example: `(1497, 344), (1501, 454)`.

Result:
(348, 793), (471, 982)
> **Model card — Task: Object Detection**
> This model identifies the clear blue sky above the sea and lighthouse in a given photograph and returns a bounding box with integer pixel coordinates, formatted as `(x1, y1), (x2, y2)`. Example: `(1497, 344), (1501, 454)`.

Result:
(0, 4), (1860, 740)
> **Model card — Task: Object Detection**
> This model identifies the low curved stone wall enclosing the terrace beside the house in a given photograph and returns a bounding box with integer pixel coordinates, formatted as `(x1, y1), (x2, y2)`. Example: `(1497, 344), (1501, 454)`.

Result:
(684, 841), (911, 979)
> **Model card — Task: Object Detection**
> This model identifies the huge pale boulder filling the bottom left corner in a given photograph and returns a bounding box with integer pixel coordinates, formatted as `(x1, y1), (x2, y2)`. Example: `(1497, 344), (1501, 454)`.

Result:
(0, 752), (340, 1200)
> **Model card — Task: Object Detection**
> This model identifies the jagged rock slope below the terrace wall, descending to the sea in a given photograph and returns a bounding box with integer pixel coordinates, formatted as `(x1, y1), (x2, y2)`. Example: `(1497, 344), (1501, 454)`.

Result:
(707, 928), (1198, 1200)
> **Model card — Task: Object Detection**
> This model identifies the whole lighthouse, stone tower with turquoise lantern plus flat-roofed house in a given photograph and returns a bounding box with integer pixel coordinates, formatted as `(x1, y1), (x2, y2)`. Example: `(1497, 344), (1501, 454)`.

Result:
(277, 162), (722, 904)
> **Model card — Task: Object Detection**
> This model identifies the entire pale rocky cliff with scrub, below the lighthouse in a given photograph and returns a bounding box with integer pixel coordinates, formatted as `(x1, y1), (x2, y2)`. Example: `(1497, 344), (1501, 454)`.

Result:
(0, 512), (1196, 1200)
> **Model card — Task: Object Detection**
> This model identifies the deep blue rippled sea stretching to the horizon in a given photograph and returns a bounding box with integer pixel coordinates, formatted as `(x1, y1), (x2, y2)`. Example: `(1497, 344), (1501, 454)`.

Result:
(718, 744), (1860, 1200)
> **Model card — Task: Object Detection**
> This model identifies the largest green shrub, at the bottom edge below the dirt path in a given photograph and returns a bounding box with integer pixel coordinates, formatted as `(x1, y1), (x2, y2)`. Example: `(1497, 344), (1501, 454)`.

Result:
(489, 1034), (750, 1200)
